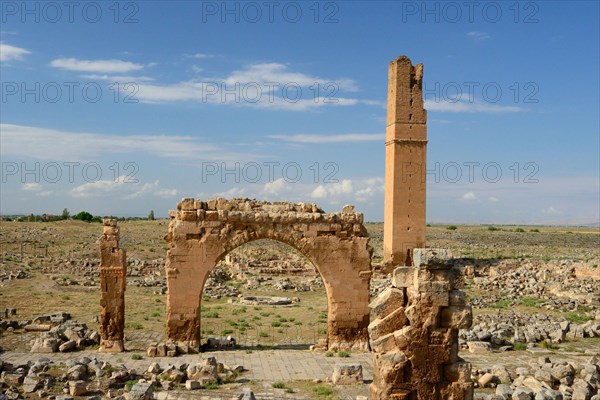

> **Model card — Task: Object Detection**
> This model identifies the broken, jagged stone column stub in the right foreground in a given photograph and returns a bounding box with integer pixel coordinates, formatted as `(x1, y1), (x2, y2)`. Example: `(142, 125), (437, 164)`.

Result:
(369, 249), (473, 400)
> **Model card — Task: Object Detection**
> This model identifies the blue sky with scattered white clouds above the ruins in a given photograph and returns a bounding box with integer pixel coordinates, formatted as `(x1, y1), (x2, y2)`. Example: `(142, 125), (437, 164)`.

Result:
(0, 1), (600, 224)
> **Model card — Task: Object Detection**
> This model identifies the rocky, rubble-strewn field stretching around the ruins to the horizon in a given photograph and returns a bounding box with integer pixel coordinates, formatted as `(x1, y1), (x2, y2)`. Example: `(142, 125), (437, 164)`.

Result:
(0, 220), (600, 400)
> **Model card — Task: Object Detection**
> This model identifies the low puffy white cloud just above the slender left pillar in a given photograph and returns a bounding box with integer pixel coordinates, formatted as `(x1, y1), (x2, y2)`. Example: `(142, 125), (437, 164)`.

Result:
(69, 176), (177, 200)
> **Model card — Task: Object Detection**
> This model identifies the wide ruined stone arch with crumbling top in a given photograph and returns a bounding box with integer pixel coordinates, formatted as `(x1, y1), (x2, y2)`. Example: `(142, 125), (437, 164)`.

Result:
(165, 198), (372, 351)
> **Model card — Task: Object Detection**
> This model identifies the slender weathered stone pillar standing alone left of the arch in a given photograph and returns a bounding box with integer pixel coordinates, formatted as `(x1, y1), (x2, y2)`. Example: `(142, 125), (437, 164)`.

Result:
(98, 219), (127, 353)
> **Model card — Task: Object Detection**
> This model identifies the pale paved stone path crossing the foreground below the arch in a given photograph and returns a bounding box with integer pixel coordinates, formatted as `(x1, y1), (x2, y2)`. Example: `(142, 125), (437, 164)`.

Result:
(0, 341), (600, 400)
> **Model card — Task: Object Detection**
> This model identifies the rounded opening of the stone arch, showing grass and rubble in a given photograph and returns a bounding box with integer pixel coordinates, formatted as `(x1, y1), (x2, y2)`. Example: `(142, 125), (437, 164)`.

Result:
(198, 239), (330, 349)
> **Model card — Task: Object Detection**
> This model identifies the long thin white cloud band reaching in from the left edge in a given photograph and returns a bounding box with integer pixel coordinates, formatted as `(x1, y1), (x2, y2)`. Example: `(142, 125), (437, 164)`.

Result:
(0, 124), (241, 161)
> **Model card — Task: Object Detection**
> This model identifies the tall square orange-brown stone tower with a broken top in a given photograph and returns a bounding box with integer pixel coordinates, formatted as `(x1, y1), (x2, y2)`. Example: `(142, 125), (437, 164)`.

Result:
(383, 56), (427, 267)
